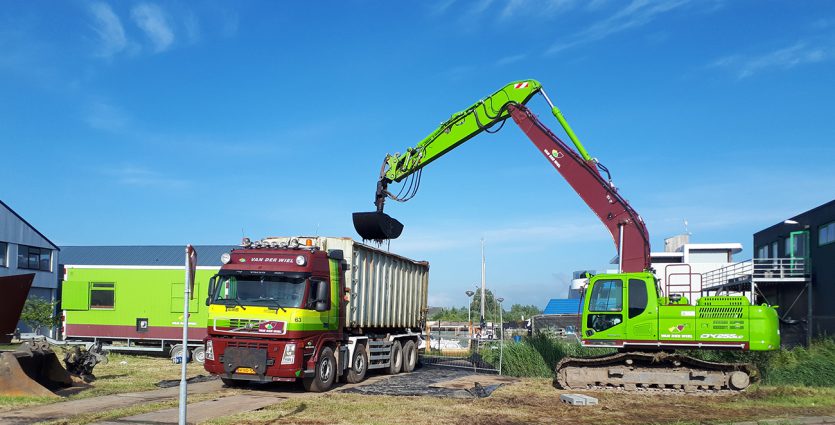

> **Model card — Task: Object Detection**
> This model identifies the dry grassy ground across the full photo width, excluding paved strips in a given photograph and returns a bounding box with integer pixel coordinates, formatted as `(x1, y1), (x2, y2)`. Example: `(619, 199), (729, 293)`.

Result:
(0, 355), (835, 425)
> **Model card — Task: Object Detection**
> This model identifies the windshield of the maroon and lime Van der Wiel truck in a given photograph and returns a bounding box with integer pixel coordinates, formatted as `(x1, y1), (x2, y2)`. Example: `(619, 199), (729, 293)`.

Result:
(215, 276), (307, 308)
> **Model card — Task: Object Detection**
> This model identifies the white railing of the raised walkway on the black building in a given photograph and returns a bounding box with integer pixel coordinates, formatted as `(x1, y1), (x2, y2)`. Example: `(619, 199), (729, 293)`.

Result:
(702, 258), (809, 290)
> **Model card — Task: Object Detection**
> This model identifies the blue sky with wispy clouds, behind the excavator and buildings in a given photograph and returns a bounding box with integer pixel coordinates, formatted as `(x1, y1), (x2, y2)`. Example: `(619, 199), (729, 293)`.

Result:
(0, 0), (835, 306)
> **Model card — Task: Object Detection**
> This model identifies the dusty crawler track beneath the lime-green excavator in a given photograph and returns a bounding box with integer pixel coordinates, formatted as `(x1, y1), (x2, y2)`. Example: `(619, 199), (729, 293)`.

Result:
(554, 352), (759, 393)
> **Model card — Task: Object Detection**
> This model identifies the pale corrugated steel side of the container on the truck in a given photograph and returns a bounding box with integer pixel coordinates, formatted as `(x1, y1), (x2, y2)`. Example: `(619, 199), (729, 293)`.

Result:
(345, 243), (429, 328)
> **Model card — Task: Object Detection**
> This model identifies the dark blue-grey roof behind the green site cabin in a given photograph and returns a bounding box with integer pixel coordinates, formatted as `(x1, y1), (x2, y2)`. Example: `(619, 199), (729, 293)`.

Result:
(61, 245), (238, 267)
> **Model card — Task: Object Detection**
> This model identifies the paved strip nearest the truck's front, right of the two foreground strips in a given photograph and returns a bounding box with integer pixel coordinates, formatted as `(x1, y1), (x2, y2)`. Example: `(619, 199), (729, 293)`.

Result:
(97, 394), (280, 425)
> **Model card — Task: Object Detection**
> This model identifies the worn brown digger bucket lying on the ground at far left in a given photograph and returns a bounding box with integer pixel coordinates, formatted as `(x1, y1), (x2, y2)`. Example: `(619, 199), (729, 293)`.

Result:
(0, 342), (72, 397)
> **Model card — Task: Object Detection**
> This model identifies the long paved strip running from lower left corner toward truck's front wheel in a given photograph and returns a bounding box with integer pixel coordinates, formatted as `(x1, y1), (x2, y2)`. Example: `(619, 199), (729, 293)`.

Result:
(0, 380), (223, 425)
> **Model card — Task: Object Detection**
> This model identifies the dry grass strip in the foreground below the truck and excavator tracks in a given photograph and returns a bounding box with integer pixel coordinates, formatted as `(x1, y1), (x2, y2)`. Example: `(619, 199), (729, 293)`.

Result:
(209, 378), (835, 425)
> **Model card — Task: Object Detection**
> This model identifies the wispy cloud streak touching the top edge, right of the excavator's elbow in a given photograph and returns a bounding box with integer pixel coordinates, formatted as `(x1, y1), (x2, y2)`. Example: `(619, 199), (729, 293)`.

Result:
(547, 0), (690, 54)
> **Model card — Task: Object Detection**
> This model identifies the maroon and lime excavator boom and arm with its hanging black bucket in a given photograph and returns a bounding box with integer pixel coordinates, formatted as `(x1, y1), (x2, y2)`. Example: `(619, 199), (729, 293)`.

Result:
(353, 80), (650, 272)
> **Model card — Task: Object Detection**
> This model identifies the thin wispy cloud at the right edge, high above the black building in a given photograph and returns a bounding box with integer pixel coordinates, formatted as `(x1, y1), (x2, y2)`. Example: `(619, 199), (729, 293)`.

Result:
(710, 42), (835, 79)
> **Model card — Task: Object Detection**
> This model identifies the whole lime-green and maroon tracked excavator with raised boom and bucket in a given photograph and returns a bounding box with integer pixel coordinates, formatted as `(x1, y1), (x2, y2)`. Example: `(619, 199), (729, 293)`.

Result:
(353, 80), (780, 392)
